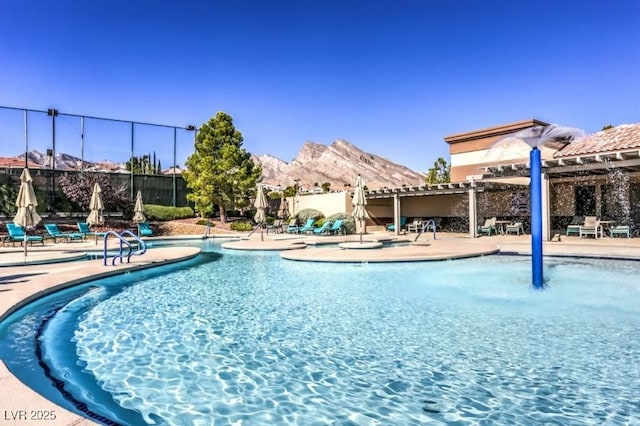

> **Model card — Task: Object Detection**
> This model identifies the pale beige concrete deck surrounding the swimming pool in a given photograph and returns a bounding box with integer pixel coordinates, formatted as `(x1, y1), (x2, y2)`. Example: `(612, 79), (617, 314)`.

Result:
(0, 232), (640, 425)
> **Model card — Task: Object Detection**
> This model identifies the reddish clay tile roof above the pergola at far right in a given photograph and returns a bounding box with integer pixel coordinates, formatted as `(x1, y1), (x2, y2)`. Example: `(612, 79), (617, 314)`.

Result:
(554, 123), (640, 158)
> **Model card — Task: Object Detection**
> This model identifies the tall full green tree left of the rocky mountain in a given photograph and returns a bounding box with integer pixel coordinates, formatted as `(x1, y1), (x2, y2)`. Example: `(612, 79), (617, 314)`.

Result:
(182, 112), (262, 222)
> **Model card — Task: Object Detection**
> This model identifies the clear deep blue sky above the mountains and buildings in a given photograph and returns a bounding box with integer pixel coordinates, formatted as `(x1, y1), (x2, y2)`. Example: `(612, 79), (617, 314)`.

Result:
(0, 0), (640, 171)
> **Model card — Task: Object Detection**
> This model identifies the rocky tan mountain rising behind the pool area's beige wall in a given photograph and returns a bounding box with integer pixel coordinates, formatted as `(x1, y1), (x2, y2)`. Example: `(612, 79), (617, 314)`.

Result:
(253, 140), (424, 189)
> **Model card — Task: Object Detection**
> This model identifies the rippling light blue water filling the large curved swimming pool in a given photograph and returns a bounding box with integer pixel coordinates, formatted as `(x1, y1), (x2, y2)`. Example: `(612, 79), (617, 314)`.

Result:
(0, 243), (640, 425)
